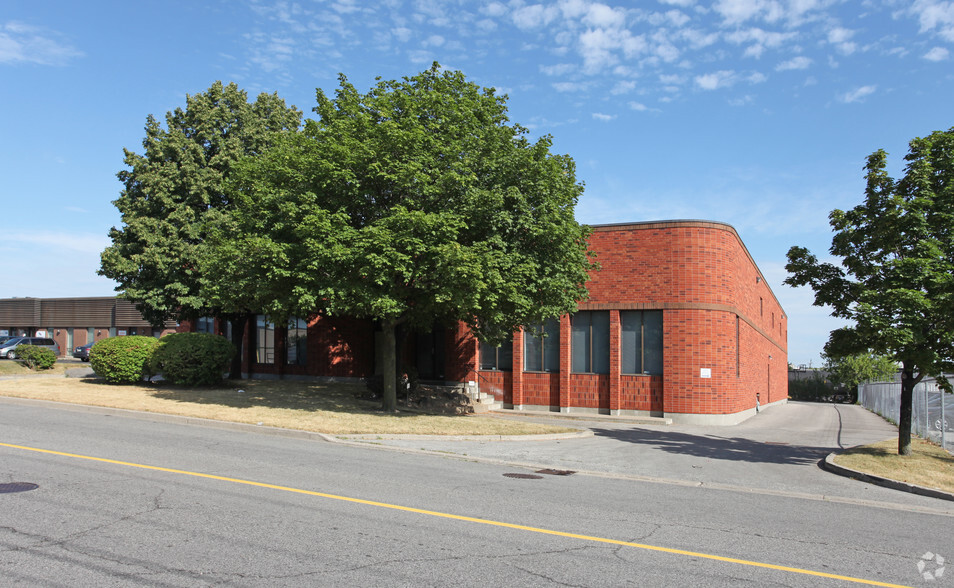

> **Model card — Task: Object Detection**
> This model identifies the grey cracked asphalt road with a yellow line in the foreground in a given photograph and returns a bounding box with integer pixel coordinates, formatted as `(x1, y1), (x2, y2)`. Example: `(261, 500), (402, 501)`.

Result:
(0, 400), (954, 586)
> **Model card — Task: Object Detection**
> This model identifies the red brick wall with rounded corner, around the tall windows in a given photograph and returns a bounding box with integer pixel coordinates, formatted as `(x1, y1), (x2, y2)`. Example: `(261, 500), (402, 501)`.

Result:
(470, 221), (788, 415)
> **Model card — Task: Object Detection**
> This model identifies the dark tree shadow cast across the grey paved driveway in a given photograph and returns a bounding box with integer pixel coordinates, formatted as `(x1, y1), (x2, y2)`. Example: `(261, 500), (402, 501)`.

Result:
(593, 429), (831, 465)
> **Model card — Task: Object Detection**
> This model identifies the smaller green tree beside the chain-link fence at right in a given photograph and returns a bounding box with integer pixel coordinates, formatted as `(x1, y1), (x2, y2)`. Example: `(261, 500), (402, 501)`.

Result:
(785, 127), (954, 455)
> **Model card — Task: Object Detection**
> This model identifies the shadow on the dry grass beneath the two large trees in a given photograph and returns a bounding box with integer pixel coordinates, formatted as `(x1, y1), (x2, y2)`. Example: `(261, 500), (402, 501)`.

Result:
(141, 380), (462, 418)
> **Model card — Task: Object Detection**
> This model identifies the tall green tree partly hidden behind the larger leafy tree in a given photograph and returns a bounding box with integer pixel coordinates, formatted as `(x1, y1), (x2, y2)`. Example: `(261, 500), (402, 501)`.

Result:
(99, 82), (301, 377)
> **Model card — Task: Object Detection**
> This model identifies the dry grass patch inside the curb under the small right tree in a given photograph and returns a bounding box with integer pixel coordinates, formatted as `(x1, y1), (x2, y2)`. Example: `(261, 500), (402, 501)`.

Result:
(835, 438), (954, 492)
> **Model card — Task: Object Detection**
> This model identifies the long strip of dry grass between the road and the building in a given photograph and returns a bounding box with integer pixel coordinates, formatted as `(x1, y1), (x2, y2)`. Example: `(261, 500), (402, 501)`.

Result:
(0, 378), (576, 435)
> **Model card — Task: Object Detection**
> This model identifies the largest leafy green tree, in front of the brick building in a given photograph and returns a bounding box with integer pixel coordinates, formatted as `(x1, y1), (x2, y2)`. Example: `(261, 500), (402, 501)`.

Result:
(209, 63), (594, 410)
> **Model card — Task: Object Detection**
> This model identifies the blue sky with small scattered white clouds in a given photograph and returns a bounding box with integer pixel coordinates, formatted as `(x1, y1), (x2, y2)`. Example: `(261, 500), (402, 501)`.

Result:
(0, 0), (954, 365)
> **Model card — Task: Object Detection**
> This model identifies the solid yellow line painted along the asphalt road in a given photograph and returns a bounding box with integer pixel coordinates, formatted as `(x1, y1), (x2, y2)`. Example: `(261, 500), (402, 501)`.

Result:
(0, 443), (911, 588)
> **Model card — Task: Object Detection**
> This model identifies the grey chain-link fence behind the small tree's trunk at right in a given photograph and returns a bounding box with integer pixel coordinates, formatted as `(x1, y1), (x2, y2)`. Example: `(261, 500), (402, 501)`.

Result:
(858, 376), (954, 453)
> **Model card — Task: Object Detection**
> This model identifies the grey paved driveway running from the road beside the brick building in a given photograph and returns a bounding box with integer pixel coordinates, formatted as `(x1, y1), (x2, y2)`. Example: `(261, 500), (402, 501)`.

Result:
(342, 402), (938, 507)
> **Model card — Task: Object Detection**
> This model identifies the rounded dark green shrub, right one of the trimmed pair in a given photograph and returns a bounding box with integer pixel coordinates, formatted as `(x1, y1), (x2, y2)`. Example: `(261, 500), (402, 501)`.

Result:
(152, 333), (235, 386)
